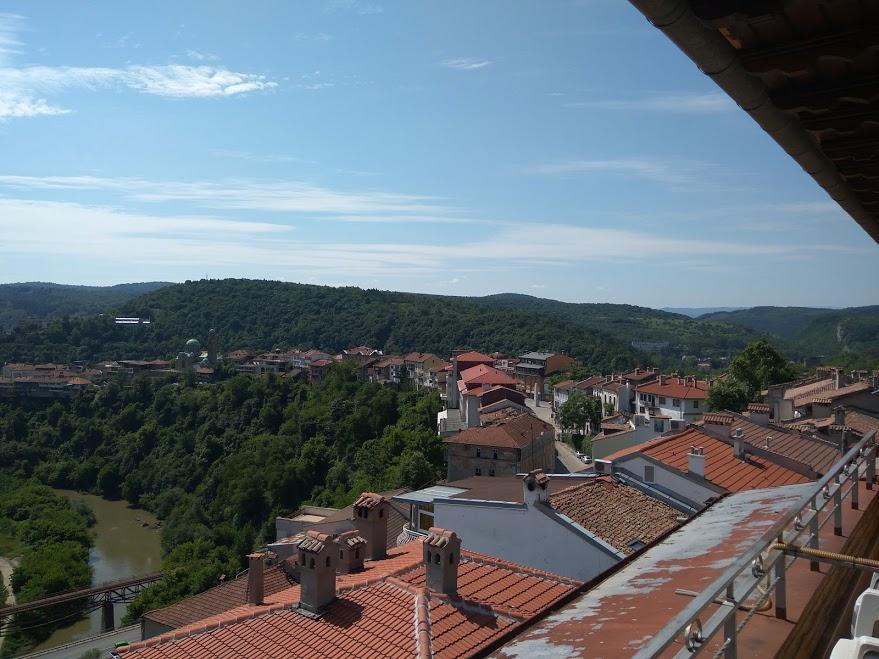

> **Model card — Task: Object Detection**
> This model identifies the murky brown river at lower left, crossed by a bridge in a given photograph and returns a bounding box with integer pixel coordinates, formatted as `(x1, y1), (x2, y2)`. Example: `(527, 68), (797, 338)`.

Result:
(31, 490), (162, 652)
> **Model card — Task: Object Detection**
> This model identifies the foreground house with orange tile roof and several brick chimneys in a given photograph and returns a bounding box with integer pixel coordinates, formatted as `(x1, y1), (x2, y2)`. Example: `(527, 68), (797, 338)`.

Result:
(124, 493), (581, 659)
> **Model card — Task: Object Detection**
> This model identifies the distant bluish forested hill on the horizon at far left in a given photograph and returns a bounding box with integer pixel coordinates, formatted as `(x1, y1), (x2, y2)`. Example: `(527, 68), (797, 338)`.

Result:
(0, 282), (168, 330)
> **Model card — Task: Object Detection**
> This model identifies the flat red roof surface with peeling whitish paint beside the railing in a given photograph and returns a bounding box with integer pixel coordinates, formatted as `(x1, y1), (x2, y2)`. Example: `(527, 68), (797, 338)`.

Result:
(495, 483), (814, 657)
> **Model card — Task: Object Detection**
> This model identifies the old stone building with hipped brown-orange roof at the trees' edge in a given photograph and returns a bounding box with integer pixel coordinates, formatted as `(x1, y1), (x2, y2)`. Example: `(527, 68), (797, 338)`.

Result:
(444, 412), (555, 480)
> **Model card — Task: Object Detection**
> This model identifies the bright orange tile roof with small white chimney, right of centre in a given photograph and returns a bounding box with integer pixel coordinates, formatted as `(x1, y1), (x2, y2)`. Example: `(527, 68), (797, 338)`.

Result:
(641, 428), (810, 492)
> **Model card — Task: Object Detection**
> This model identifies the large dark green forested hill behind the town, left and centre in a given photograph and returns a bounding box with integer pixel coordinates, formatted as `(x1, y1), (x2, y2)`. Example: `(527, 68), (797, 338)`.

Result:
(0, 279), (645, 371)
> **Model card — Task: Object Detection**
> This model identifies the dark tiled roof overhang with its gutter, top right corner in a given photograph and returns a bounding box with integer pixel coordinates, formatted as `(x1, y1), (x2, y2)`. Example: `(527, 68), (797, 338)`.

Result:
(629, 0), (879, 242)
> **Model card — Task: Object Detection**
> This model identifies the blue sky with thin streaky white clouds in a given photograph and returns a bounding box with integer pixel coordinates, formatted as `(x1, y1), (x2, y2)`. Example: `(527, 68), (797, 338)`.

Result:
(0, 0), (879, 307)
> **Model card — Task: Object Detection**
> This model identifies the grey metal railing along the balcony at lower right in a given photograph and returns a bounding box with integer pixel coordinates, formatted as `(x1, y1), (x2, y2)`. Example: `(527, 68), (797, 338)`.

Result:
(636, 431), (876, 659)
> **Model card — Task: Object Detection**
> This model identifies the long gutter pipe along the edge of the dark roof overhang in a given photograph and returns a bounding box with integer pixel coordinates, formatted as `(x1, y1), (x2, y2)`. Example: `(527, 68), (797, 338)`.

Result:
(629, 0), (879, 242)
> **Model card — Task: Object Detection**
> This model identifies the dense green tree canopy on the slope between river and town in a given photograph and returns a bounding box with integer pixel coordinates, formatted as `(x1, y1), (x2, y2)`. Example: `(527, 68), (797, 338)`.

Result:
(0, 364), (444, 624)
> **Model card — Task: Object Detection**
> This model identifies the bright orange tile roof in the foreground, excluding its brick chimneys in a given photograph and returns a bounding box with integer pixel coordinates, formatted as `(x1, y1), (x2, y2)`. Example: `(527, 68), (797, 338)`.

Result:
(118, 542), (580, 659)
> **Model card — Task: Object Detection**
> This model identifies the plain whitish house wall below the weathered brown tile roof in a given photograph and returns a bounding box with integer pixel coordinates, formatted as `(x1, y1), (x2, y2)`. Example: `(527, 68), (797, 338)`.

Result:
(433, 499), (619, 581)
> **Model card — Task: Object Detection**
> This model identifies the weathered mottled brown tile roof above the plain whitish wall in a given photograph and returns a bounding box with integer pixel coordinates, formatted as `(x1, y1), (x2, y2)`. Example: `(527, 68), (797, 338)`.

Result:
(549, 477), (679, 554)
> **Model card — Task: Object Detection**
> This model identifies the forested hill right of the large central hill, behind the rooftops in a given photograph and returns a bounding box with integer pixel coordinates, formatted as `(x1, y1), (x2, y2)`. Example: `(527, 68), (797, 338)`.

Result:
(473, 293), (760, 357)
